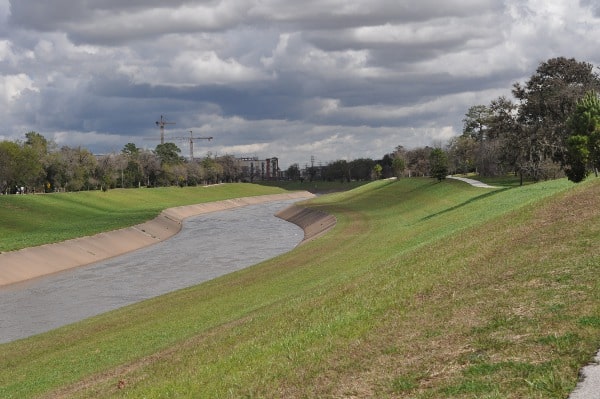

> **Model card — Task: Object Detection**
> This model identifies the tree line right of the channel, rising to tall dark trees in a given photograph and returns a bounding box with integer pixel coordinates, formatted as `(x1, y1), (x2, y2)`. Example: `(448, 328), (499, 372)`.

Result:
(288, 57), (600, 183)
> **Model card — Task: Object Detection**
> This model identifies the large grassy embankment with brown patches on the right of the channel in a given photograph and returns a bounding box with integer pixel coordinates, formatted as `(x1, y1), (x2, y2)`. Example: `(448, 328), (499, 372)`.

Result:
(0, 179), (600, 398)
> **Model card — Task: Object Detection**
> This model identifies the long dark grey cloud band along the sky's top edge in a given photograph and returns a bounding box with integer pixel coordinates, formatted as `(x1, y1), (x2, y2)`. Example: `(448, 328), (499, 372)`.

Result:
(10, 0), (500, 45)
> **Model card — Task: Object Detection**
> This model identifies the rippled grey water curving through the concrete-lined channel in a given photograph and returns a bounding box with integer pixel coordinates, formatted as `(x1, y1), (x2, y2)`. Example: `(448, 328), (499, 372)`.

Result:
(0, 200), (304, 343)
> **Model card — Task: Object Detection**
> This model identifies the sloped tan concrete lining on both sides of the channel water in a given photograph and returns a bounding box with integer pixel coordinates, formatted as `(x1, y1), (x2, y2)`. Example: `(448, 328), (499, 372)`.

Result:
(0, 191), (335, 286)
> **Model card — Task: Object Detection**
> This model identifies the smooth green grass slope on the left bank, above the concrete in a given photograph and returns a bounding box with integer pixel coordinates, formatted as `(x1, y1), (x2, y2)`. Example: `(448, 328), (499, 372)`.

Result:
(0, 184), (284, 252)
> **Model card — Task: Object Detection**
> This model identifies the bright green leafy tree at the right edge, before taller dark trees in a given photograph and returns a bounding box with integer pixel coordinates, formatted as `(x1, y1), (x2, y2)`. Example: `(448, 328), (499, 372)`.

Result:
(565, 92), (600, 183)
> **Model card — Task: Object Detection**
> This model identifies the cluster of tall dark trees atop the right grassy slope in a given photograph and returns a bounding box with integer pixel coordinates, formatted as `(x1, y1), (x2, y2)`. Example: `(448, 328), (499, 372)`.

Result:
(447, 57), (600, 182)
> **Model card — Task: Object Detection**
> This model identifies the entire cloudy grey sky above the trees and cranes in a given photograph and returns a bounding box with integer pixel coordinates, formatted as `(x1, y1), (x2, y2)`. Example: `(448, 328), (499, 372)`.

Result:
(0, 0), (600, 169)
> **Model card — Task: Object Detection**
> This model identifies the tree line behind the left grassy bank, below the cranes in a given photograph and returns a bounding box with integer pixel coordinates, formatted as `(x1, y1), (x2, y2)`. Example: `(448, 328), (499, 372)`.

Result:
(0, 131), (241, 194)
